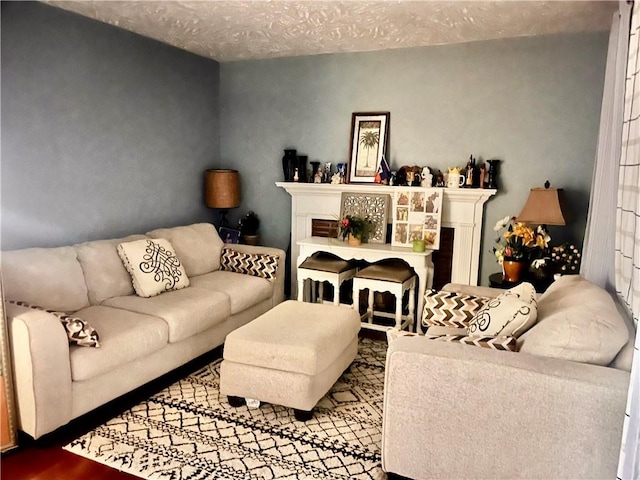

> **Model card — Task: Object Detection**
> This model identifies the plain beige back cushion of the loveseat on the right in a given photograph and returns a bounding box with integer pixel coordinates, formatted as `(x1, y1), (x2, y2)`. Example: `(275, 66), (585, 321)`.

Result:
(518, 275), (629, 365)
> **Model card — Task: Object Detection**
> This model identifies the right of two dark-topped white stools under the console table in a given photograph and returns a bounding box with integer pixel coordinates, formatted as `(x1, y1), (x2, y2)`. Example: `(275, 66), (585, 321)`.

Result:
(353, 259), (416, 331)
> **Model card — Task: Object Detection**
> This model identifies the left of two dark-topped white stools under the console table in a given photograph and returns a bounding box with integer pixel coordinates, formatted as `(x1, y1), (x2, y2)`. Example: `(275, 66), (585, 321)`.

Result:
(298, 252), (358, 305)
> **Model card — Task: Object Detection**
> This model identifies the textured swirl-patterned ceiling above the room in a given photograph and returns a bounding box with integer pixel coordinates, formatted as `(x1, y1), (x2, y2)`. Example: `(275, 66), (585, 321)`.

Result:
(46, 0), (617, 62)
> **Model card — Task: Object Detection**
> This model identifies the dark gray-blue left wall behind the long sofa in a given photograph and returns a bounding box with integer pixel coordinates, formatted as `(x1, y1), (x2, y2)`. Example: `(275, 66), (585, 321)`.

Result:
(1, 2), (220, 249)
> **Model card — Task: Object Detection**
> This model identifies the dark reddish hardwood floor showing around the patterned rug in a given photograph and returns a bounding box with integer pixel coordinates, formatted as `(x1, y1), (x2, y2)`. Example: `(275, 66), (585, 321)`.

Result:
(0, 330), (390, 480)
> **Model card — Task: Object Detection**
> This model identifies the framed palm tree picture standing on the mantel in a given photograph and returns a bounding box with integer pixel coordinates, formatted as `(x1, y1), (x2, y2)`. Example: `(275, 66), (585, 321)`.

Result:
(347, 112), (390, 183)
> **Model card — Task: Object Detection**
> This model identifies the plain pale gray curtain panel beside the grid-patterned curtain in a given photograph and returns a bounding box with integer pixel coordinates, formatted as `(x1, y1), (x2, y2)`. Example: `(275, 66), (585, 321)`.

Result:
(580, 2), (630, 293)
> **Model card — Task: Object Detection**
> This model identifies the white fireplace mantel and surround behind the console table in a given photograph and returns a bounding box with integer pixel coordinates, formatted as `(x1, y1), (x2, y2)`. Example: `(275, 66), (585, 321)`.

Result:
(276, 182), (496, 292)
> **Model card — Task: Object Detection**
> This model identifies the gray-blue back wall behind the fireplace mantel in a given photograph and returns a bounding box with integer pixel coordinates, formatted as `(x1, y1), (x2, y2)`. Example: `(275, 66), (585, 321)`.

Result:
(220, 33), (608, 284)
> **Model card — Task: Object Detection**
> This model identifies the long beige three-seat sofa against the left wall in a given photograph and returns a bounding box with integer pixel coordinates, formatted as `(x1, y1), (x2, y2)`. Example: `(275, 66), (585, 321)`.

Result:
(2, 223), (285, 438)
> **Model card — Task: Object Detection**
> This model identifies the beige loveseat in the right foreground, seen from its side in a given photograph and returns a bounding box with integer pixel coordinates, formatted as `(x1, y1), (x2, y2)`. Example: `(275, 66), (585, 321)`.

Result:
(382, 276), (635, 479)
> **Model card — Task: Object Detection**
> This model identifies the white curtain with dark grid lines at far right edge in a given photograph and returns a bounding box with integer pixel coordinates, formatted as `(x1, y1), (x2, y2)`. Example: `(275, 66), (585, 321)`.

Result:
(615, 2), (640, 479)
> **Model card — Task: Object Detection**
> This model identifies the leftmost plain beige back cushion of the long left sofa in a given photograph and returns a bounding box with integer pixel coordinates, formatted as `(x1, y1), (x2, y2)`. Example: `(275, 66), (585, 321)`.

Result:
(1, 247), (89, 312)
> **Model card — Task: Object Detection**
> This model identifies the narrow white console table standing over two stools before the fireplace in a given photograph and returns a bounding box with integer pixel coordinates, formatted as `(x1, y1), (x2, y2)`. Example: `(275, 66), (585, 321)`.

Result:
(296, 237), (433, 326)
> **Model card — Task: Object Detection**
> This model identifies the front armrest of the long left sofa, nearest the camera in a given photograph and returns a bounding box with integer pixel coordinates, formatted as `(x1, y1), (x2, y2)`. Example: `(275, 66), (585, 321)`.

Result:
(5, 303), (72, 438)
